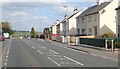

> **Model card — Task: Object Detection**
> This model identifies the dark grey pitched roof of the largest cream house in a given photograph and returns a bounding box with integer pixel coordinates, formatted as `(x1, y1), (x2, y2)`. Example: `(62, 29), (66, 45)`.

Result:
(78, 2), (111, 17)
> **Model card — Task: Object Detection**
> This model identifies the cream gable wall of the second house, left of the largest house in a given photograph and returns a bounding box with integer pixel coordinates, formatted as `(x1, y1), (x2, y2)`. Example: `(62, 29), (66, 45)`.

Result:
(68, 12), (81, 35)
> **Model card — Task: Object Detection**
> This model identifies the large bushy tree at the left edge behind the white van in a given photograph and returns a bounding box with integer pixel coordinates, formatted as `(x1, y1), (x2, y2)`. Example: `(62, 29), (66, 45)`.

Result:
(2, 22), (14, 35)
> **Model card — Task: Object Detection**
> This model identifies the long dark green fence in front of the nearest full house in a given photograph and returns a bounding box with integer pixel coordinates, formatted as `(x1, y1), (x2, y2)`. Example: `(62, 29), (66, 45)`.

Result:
(79, 37), (120, 48)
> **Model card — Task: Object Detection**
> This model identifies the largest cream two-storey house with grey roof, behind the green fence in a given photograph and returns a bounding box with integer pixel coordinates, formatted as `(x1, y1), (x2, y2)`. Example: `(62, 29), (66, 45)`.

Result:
(76, 0), (118, 36)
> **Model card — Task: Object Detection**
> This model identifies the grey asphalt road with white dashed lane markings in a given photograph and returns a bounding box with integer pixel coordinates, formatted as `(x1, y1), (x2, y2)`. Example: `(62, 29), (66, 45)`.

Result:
(2, 39), (118, 67)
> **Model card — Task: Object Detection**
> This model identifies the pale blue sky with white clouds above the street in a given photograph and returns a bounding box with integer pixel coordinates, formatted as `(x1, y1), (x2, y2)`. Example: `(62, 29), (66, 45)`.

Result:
(0, 0), (111, 32)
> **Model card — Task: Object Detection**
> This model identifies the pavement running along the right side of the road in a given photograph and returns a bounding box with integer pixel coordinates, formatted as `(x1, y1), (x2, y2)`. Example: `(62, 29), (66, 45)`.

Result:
(47, 40), (120, 62)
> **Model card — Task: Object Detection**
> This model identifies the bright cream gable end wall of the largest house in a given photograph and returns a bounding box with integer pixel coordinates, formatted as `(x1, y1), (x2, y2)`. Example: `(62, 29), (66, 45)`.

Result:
(99, 1), (118, 35)
